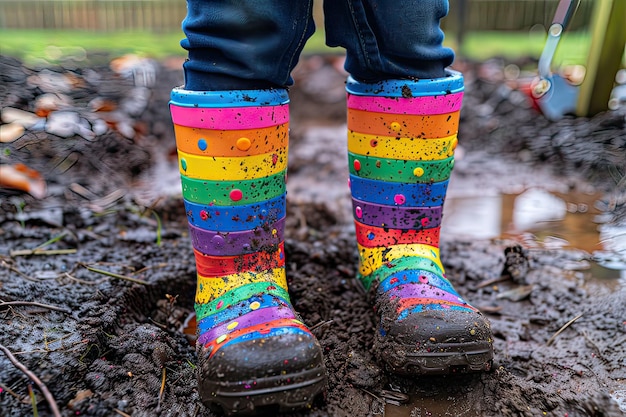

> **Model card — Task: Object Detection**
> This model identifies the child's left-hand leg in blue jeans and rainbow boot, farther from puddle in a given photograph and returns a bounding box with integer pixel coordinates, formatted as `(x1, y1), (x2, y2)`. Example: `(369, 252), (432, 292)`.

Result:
(170, 0), (326, 414)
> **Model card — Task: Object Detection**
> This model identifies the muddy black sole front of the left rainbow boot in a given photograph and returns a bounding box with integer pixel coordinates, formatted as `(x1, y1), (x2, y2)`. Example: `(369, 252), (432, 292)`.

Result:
(202, 368), (326, 416)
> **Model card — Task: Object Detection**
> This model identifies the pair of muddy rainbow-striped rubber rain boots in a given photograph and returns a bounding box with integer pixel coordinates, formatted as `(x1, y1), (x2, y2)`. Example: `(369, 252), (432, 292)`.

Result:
(170, 72), (493, 415)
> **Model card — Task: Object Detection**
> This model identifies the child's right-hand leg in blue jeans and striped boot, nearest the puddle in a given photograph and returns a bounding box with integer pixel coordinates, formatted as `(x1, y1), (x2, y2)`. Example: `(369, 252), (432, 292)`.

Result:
(325, 0), (493, 374)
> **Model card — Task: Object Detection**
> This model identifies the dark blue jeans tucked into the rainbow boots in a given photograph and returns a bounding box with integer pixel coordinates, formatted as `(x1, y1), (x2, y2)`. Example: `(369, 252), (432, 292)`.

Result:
(181, 0), (454, 91)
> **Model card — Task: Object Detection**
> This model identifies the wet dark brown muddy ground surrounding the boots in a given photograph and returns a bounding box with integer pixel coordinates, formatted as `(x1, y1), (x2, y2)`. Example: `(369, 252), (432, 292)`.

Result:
(0, 56), (626, 417)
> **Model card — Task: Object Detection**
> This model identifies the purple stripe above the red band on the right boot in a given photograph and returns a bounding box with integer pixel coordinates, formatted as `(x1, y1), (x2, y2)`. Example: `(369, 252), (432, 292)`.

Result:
(352, 198), (443, 230)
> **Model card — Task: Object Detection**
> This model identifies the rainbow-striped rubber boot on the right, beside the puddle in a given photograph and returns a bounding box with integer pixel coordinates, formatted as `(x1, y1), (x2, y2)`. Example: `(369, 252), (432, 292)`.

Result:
(346, 71), (493, 375)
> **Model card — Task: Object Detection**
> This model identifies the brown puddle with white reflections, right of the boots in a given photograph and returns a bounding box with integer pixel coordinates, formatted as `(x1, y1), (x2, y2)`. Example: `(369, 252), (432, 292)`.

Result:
(442, 188), (626, 287)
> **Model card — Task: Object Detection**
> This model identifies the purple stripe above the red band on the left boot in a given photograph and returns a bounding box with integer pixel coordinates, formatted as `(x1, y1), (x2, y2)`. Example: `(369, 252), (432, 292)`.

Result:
(189, 217), (285, 256)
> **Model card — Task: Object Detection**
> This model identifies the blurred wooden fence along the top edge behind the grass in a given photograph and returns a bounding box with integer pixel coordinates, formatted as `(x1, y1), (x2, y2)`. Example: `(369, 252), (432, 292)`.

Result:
(0, 0), (593, 32)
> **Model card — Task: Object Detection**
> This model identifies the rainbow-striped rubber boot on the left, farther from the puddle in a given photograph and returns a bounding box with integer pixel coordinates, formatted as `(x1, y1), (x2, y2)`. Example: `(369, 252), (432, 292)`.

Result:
(170, 89), (326, 415)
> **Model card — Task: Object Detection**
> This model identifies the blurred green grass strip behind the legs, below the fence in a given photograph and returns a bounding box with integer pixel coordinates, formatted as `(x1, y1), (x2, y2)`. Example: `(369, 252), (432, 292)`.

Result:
(0, 30), (589, 64)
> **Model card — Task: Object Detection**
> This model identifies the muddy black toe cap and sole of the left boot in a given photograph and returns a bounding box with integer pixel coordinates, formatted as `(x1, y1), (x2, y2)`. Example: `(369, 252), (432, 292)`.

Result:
(198, 329), (326, 414)
